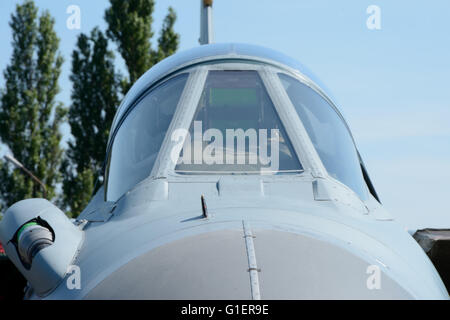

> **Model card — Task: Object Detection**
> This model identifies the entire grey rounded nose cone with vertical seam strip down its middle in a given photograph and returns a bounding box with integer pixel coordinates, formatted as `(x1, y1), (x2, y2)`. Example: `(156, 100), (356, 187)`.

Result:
(86, 224), (410, 300)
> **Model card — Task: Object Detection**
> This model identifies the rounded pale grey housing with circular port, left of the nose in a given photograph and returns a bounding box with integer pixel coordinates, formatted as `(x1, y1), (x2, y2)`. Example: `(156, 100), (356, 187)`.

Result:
(0, 199), (83, 296)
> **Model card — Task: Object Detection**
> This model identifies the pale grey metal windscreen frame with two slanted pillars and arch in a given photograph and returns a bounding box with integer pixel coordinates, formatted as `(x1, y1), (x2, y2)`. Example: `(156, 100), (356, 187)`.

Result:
(105, 59), (372, 199)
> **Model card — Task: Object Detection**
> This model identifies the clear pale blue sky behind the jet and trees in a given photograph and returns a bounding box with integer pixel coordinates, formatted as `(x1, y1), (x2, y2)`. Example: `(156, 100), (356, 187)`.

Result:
(0, 0), (450, 228)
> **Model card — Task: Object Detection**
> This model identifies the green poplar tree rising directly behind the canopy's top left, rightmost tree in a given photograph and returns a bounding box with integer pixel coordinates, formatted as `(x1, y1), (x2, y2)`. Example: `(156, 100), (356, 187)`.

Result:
(105, 0), (179, 92)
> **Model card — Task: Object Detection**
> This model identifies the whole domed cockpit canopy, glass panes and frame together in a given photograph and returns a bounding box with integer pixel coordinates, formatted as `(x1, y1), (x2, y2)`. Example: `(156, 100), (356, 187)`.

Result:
(105, 45), (367, 201)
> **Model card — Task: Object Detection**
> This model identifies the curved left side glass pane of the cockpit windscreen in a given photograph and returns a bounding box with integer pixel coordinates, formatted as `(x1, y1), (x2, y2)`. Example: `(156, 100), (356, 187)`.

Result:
(107, 74), (188, 201)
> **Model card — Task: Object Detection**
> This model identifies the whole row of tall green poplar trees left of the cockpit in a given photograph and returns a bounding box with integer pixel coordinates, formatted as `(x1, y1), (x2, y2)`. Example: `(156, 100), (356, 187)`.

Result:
(0, 0), (179, 216)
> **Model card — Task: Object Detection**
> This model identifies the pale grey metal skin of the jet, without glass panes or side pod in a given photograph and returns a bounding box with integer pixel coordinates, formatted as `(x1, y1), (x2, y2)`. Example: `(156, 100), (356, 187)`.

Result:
(0, 44), (449, 299)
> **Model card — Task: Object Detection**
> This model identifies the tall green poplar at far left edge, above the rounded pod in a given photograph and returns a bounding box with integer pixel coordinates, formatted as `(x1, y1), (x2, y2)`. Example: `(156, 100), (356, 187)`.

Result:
(0, 0), (66, 212)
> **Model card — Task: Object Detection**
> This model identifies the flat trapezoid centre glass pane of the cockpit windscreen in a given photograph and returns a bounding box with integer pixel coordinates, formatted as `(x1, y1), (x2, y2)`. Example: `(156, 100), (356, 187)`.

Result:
(175, 71), (303, 174)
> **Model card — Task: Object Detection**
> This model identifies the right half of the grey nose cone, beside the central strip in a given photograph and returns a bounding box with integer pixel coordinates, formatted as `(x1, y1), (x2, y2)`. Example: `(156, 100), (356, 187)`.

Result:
(254, 230), (412, 299)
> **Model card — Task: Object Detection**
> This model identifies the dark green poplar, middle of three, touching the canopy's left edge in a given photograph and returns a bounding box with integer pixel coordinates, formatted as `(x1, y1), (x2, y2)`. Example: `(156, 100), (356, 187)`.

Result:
(62, 28), (121, 216)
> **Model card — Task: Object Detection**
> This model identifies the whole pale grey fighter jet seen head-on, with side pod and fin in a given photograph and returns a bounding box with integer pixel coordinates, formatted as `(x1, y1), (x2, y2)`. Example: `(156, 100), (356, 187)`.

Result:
(0, 1), (449, 300)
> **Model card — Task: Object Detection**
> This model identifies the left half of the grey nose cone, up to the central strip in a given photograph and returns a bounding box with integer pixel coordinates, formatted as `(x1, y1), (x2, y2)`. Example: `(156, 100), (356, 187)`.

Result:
(87, 230), (251, 300)
